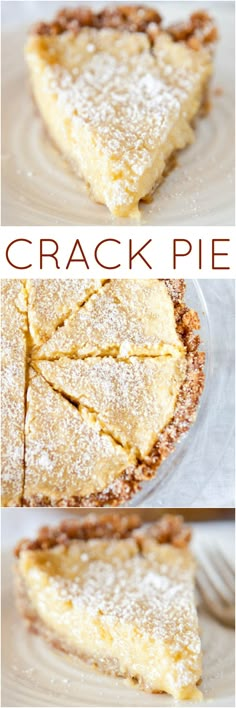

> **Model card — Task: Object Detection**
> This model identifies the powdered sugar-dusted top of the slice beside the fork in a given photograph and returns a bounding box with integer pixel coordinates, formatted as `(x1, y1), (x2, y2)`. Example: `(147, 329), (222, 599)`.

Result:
(25, 539), (201, 688)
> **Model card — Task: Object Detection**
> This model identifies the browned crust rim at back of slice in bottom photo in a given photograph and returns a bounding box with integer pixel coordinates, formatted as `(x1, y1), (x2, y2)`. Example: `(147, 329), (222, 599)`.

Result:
(15, 513), (191, 557)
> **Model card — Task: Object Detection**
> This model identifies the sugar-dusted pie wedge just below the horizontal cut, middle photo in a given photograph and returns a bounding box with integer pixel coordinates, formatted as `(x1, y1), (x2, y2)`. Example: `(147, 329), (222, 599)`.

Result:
(34, 356), (186, 460)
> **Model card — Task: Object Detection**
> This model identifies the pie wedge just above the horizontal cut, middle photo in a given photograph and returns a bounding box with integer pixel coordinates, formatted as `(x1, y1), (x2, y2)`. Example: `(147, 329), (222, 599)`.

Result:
(32, 279), (184, 359)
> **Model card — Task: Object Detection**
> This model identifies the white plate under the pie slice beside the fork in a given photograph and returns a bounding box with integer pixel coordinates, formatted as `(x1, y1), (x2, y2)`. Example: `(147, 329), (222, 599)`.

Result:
(2, 509), (235, 708)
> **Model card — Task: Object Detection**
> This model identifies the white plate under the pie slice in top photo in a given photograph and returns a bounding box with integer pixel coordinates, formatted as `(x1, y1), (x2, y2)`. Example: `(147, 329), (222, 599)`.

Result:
(2, 1), (234, 226)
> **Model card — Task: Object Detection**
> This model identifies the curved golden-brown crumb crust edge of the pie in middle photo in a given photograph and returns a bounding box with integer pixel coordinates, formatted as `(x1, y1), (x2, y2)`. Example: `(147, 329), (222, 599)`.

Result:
(23, 279), (205, 508)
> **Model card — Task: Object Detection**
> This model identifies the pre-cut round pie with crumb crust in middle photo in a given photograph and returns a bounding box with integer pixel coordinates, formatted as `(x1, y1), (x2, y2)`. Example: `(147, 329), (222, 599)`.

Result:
(2, 279), (204, 506)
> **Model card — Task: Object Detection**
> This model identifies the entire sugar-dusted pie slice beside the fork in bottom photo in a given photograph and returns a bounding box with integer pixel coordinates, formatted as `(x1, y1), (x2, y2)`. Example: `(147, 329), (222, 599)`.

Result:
(16, 512), (202, 700)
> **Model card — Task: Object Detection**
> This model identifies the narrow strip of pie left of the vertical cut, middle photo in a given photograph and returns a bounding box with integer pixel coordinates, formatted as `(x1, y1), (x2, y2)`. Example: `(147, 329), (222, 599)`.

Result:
(1, 280), (27, 506)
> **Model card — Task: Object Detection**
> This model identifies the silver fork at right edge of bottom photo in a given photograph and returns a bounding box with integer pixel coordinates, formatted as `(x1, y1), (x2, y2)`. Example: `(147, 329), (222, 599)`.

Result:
(196, 548), (235, 627)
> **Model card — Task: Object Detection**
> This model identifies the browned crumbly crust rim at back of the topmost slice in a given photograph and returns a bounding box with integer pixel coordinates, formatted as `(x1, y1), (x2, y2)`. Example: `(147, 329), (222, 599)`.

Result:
(32, 5), (218, 49)
